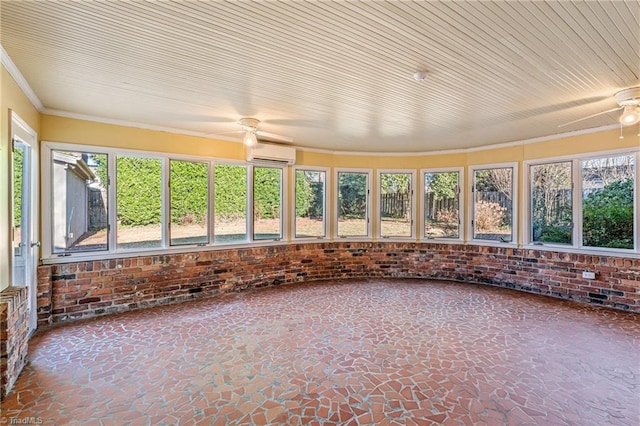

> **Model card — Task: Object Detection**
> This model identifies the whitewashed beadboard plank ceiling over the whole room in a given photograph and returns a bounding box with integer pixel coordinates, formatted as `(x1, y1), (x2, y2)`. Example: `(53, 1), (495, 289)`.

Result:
(0, 0), (640, 152)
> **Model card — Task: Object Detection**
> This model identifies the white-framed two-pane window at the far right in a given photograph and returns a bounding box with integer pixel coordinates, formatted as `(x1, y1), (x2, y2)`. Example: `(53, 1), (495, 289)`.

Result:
(528, 154), (640, 250)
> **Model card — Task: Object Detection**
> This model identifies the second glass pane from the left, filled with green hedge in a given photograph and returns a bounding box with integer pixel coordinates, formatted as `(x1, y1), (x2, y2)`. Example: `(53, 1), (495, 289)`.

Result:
(116, 157), (162, 249)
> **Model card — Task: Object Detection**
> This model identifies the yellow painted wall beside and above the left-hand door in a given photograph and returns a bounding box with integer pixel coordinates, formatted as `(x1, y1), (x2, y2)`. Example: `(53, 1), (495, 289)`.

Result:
(0, 66), (40, 290)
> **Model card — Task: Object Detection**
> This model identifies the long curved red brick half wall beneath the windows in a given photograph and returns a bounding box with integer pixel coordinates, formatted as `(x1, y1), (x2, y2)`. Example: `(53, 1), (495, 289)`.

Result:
(38, 242), (640, 325)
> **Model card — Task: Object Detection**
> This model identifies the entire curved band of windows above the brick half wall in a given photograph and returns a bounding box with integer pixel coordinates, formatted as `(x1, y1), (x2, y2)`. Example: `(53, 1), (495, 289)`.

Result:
(43, 144), (640, 257)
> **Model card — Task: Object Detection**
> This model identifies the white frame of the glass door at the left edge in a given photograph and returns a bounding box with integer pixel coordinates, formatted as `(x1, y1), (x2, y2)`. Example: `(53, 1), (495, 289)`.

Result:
(9, 110), (40, 333)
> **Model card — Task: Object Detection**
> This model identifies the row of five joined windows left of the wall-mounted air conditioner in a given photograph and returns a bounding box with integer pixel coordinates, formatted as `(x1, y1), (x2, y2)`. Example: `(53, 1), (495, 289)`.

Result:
(44, 149), (288, 256)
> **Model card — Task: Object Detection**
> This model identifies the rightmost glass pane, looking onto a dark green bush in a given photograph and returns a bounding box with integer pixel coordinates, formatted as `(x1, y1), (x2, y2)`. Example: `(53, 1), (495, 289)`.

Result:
(582, 155), (637, 249)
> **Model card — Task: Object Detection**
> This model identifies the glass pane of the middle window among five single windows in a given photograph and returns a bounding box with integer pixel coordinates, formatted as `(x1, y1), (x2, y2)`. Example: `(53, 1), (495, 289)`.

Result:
(380, 173), (413, 237)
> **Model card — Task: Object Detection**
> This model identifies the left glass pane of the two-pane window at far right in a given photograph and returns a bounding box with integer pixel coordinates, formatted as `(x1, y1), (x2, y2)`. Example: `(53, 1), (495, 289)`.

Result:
(531, 162), (573, 244)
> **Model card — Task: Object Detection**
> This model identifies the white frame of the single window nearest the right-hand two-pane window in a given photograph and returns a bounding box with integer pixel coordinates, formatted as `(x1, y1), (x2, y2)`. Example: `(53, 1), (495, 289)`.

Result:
(466, 161), (520, 247)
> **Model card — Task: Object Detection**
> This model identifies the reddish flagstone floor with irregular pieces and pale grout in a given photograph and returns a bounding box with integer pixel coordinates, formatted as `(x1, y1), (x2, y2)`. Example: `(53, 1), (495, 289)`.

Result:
(0, 279), (640, 426)
